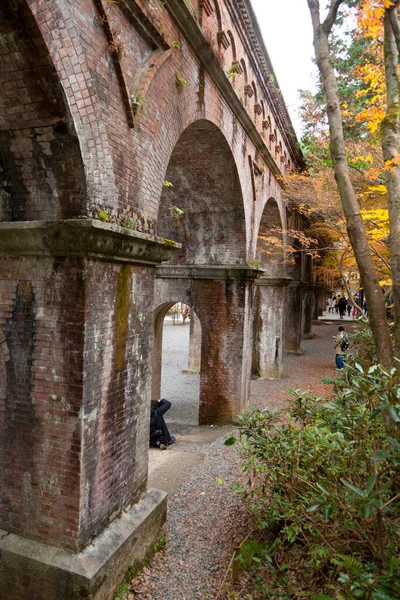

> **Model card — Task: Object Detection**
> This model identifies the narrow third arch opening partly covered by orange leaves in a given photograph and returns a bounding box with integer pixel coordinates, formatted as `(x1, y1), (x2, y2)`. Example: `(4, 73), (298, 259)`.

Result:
(256, 198), (286, 277)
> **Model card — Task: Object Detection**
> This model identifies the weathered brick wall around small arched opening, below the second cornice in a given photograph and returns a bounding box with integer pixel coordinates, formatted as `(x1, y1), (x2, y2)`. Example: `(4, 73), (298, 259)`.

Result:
(153, 277), (253, 424)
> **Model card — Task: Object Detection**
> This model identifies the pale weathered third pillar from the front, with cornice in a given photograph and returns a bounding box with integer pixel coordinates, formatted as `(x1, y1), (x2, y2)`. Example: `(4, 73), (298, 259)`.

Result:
(252, 278), (289, 379)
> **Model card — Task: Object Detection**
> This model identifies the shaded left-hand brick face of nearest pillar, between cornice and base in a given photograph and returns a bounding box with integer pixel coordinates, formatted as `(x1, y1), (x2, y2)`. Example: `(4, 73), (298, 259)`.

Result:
(0, 258), (84, 548)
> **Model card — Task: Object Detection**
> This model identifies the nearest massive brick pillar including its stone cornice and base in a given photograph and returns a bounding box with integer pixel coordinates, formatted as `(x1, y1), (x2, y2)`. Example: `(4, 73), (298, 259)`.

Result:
(0, 219), (177, 600)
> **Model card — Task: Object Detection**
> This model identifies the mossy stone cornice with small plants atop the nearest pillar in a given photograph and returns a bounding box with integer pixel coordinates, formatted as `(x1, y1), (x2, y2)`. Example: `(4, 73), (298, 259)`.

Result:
(0, 219), (181, 266)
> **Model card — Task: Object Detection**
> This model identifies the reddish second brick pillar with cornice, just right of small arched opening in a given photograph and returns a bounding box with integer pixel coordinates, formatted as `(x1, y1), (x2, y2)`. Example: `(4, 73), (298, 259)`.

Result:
(192, 267), (258, 425)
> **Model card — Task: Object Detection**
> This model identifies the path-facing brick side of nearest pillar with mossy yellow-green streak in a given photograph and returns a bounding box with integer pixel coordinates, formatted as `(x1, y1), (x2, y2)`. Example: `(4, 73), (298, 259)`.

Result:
(80, 262), (153, 543)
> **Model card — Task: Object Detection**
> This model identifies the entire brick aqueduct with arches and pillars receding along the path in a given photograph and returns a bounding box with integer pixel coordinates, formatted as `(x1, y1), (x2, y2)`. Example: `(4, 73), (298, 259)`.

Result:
(0, 0), (324, 600)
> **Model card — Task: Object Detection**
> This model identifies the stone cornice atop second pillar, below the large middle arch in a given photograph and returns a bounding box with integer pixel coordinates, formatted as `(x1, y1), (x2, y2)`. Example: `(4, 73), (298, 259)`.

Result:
(156, 265), (264, 281)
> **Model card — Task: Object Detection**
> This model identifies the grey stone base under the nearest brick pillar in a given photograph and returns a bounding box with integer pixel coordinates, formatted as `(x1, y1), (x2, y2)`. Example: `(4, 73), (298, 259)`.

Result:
(0, 489), (167, 600)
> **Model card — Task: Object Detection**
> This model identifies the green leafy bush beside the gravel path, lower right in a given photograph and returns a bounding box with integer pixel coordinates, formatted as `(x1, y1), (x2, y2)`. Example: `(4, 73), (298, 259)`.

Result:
(226, 361), (400, 600)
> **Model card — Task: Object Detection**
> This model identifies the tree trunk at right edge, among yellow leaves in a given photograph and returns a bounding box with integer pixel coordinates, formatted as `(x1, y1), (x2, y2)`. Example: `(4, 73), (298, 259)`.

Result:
(381, 6), (400, 358)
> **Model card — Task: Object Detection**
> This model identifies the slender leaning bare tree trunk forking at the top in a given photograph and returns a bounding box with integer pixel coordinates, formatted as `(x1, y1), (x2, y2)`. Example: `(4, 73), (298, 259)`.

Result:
(307, 0), (393, 366)
